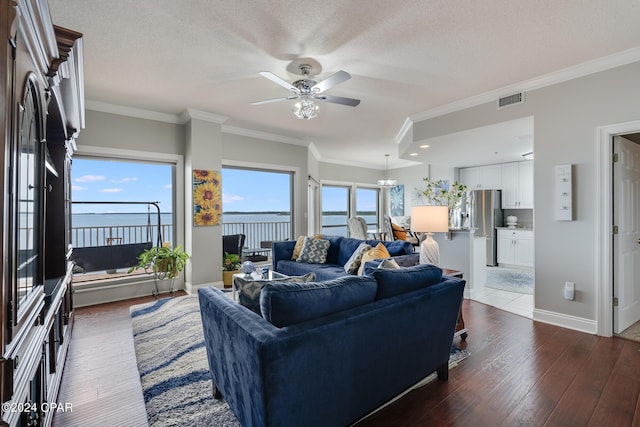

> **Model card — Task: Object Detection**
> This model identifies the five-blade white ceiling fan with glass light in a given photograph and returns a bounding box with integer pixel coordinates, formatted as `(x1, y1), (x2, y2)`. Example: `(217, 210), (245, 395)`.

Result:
(251, 64), (360, 120)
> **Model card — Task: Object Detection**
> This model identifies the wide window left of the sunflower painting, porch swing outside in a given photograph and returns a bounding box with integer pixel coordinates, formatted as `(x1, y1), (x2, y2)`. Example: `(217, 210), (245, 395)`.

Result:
(71, 156), (176, 272)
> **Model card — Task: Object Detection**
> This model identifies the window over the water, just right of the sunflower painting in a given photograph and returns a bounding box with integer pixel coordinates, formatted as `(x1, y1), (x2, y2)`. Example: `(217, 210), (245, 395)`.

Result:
(222, 166), (294, 248)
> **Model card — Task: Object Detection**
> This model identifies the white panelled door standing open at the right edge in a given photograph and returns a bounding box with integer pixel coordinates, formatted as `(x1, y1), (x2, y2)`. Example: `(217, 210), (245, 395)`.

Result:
(613, 136), (640, 333)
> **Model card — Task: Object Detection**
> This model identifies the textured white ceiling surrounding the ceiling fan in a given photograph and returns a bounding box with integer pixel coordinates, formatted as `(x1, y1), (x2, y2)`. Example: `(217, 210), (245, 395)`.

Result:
(49, 0), (640, 172)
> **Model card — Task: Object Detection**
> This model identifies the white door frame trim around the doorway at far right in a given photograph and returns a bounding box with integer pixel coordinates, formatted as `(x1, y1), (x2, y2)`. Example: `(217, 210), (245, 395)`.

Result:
(595, 120), (640, 337)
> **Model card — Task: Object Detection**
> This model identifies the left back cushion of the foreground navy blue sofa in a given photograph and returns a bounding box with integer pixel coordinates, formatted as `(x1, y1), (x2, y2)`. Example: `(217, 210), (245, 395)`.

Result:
(260, 276), (377, 328)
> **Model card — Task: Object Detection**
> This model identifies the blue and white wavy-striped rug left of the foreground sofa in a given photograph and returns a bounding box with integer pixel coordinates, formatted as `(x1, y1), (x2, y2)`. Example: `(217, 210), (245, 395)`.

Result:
(130, 295), (240, 427)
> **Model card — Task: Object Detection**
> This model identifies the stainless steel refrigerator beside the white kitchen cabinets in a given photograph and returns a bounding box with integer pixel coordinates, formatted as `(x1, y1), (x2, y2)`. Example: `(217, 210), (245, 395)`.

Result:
(468, 190), (503, 266)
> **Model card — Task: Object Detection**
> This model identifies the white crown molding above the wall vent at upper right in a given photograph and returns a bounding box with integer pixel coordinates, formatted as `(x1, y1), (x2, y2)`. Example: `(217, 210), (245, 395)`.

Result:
(405, 47), (640, 123)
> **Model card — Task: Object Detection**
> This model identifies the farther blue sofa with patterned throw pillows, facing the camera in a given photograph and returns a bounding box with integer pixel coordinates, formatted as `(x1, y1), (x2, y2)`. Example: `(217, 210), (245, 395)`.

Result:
(272, 236), (417, 281)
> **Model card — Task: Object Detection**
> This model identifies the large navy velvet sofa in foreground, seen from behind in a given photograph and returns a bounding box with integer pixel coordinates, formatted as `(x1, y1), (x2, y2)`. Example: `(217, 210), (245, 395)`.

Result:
(198, 265), (465, 427)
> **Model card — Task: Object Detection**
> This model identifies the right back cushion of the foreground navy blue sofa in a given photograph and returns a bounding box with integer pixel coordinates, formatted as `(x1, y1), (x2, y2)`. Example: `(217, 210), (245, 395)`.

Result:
(373, 264), (442, 299)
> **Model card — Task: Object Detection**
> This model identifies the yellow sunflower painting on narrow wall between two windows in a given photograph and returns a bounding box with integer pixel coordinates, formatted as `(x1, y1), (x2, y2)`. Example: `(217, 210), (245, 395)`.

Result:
(193, 169), (222, 226)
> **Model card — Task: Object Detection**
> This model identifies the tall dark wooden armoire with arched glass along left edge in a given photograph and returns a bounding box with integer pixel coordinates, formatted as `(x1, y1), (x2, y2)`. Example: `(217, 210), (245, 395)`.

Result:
(0, 0), (84, 426)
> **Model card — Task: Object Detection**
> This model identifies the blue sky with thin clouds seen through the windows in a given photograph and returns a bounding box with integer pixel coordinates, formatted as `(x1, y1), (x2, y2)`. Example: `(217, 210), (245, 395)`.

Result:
(71, 157), (376, 213)
